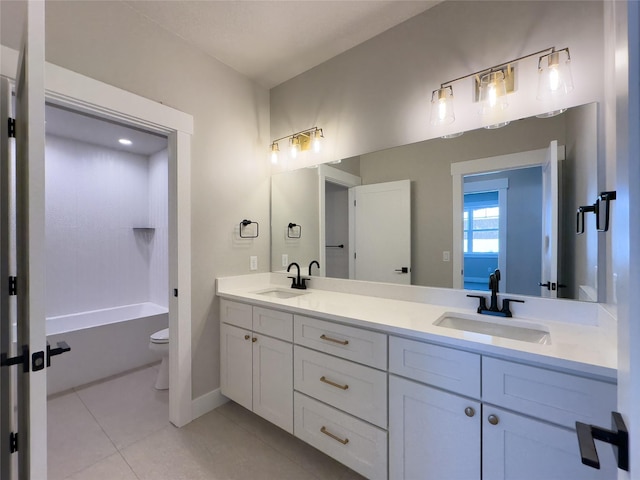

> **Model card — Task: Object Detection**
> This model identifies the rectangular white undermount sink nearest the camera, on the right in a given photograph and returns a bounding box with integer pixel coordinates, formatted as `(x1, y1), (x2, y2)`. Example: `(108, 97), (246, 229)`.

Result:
(433, 312), (551, 345)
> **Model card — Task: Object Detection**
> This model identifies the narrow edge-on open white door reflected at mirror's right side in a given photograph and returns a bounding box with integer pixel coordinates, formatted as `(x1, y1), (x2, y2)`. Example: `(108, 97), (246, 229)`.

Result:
(540, 140), (558, 298)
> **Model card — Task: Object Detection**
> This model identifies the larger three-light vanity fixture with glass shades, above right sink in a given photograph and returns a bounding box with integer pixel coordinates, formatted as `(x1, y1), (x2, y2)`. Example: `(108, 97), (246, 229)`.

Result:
(431, 47), (573, 128)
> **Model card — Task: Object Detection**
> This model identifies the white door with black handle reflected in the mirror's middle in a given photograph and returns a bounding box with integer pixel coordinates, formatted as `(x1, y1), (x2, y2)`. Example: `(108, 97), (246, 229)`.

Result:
(349, 180), (411, 285)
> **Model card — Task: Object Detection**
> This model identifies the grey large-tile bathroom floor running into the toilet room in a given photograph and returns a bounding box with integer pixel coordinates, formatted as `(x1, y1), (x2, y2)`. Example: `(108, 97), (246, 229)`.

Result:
(48, 366), (363, 480)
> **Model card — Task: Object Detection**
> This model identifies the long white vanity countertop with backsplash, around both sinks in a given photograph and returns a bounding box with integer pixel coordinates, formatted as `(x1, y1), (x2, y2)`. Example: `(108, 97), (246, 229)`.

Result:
(216, 274), (617, 381)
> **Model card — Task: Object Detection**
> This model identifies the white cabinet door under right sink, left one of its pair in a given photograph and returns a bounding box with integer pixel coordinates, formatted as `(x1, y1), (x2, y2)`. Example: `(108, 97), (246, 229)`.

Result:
(389, 375), (478, 480)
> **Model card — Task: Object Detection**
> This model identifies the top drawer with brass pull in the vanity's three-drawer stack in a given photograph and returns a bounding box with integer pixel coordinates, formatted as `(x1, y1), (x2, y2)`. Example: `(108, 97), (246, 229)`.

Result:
(294, 315), (387, 370)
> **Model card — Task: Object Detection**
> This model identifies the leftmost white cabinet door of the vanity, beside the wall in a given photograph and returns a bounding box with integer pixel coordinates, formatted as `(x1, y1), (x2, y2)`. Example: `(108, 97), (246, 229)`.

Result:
(220, 323), (253, 410)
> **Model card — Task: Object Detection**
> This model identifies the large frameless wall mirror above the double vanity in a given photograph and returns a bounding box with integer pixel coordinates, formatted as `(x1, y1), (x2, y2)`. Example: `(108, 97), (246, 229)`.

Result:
(271, 103), (606, 301)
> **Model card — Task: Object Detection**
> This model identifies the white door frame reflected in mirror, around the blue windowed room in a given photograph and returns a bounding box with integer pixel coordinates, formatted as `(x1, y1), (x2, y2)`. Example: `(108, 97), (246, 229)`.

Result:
(451, 145), (565, 289)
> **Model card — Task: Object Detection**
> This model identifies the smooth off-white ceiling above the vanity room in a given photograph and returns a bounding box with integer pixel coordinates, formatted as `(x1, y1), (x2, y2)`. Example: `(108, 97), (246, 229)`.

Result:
(0, 0), (442, 88)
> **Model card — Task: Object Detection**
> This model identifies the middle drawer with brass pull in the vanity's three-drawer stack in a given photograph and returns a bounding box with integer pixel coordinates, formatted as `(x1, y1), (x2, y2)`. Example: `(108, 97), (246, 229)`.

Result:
(293, 346), (387, 428)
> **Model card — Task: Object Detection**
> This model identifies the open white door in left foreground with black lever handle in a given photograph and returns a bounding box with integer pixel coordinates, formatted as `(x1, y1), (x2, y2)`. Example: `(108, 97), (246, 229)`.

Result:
(13, 2), (47, 480)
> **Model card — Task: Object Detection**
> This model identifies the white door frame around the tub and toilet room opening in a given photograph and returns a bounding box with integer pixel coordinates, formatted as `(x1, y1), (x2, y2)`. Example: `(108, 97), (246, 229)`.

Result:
(0, 46), (193, 427)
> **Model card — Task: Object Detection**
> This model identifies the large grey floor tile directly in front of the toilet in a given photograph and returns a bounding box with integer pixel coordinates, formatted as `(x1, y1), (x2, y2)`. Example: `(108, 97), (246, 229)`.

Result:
(77, 367), (169, 449)
